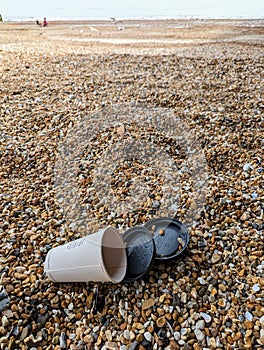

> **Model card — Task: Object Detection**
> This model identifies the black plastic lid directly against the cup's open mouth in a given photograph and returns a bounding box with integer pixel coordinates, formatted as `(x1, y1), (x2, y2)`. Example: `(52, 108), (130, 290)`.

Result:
(122, 226), (155, 282)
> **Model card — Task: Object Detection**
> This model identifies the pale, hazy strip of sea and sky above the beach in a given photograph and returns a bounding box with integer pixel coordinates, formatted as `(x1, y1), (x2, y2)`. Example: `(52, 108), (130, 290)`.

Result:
(0, 0), (264, 20)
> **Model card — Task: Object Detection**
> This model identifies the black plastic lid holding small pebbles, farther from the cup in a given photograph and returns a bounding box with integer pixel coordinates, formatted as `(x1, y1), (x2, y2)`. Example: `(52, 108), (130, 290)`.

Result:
(144, 217), (189, 260)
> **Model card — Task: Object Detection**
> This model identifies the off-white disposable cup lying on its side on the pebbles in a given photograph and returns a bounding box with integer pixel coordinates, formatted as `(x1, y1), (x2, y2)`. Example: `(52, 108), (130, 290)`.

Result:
(44, 227), (127, 283)
